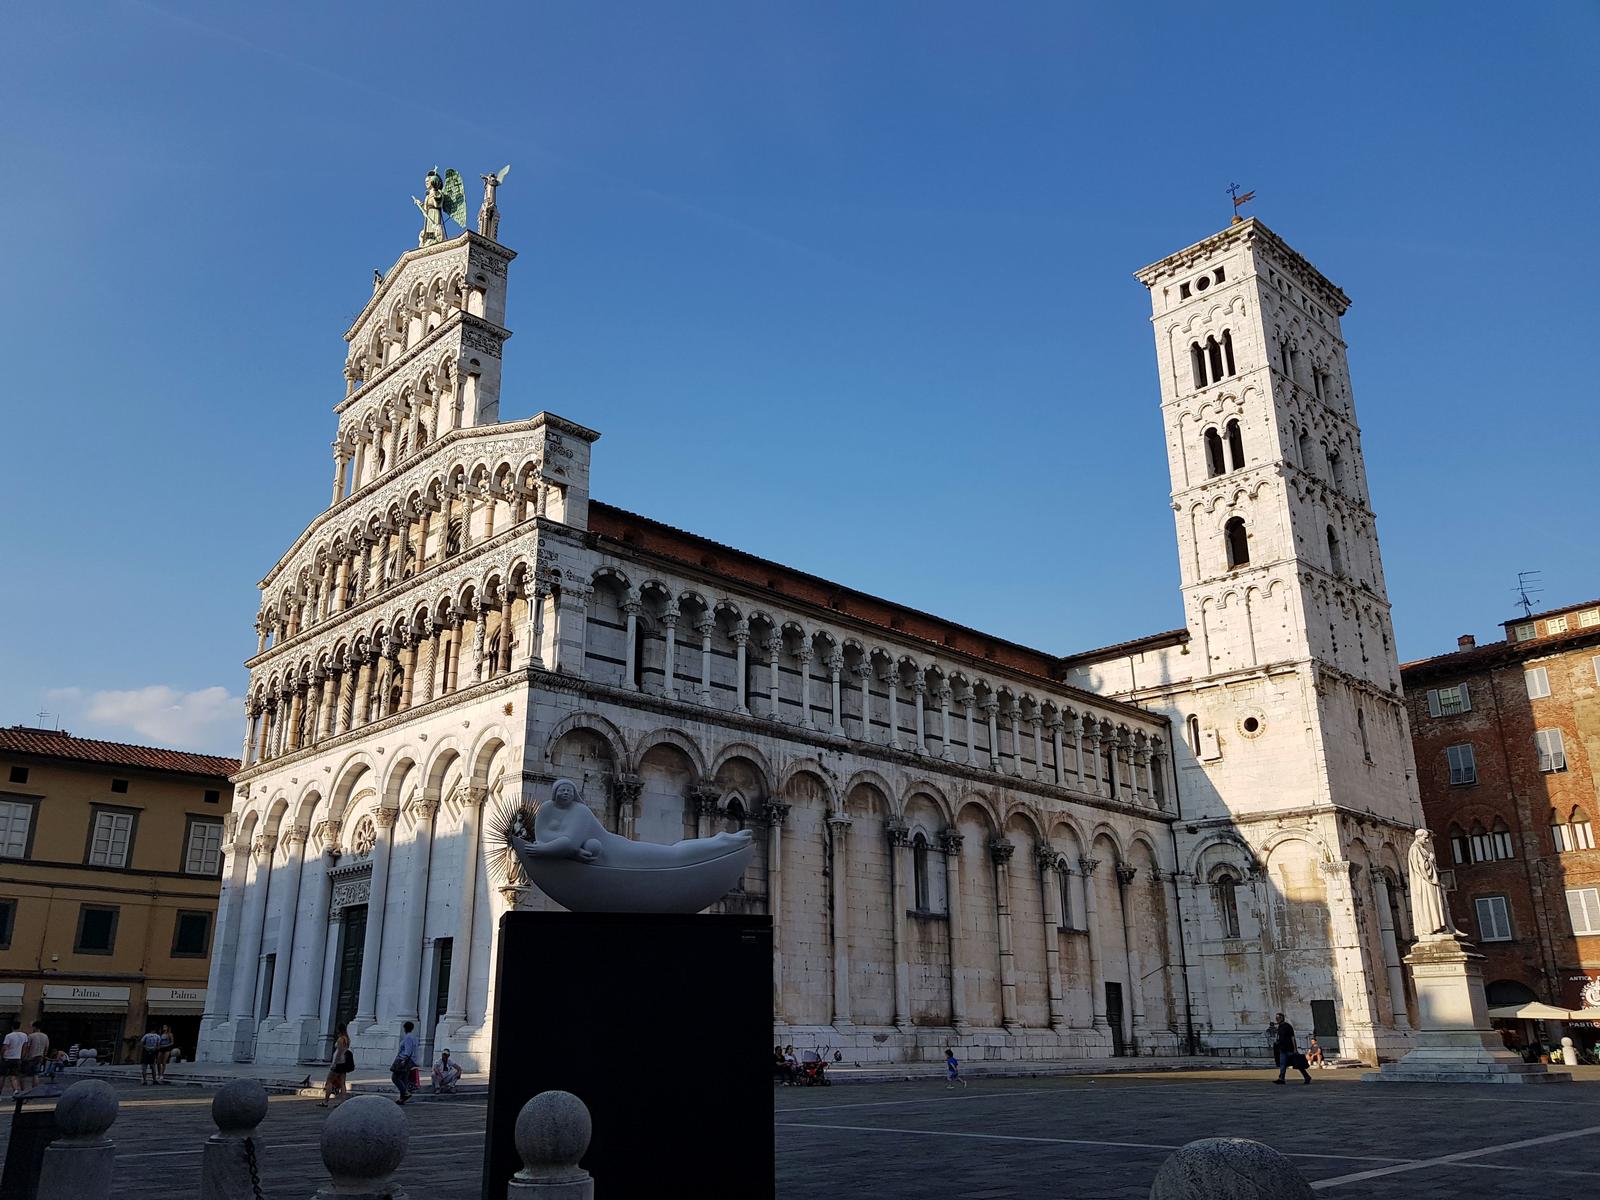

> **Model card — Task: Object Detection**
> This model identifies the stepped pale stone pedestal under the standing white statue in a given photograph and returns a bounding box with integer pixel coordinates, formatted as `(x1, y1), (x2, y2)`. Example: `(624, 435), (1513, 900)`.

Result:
(1362, 934), (1573, 1083)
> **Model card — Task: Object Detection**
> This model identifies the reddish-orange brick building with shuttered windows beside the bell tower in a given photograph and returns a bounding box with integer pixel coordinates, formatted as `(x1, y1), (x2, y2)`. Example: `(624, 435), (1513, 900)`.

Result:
(1400, 600), (1600, 1040)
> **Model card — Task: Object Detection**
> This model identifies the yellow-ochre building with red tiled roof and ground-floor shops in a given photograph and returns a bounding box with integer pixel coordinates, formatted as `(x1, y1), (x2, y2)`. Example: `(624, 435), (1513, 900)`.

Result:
(0, 725), (238, 1061)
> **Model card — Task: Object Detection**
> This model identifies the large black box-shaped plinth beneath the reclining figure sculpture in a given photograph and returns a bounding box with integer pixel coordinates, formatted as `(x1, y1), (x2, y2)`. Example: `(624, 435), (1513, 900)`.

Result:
(483, 912), (773, 1200)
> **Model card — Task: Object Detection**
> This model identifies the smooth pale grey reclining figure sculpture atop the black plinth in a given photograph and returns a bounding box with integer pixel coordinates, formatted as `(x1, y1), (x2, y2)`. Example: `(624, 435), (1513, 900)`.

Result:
(510, 779), (755, 912)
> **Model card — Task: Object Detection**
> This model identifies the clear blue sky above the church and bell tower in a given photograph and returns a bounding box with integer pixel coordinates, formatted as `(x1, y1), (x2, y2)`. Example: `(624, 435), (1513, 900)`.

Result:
(0, 0), (1600, 752)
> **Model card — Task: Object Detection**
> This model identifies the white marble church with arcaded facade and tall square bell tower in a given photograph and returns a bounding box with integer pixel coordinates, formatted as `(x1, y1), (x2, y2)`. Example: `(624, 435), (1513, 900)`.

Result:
(200, 197), (1419, 1069)
